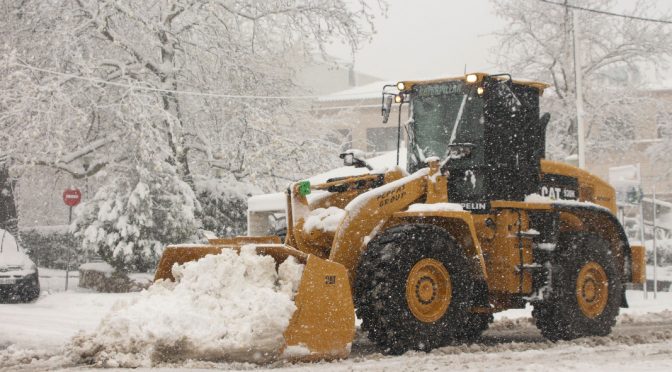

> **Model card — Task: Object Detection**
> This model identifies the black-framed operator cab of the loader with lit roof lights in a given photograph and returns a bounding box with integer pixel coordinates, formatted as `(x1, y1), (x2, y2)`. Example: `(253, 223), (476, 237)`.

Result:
(383, 73), (549, 212)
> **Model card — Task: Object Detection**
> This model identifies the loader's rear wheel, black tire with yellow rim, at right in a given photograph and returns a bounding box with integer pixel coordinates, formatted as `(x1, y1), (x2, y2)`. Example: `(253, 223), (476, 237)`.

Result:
(532, 232), (622, 341)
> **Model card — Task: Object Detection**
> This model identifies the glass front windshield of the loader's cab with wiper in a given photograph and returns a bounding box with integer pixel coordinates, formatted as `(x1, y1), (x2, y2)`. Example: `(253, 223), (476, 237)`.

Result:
(408, 81), (483, 171)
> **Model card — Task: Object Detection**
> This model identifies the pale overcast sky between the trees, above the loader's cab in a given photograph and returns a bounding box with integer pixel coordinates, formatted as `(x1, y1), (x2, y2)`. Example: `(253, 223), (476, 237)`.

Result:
(329, 0), (672, 81)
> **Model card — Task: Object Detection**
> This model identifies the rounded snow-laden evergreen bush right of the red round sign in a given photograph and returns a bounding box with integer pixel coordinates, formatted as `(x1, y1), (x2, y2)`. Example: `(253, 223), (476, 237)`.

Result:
(74, 163), (200, 272)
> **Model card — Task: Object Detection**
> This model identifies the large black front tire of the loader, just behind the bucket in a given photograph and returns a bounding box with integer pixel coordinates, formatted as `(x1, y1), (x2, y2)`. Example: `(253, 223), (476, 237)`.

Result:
(354, 224), (490, 354)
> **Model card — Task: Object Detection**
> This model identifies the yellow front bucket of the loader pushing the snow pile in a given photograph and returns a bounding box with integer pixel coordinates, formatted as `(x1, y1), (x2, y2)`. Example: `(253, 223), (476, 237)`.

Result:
(154, 237), (355, 361)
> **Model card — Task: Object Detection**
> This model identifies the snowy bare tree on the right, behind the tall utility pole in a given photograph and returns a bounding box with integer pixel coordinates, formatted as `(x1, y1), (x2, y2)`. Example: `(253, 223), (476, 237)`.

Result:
(492, 0), (672, 159)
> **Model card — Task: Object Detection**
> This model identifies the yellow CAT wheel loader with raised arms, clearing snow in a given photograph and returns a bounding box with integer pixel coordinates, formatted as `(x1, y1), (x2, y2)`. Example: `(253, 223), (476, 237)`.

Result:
(156, 73), (645, 360)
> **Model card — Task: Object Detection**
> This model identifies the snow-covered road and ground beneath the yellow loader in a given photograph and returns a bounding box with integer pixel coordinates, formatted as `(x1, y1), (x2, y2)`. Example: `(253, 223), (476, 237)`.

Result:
(0, 269), (672, 371)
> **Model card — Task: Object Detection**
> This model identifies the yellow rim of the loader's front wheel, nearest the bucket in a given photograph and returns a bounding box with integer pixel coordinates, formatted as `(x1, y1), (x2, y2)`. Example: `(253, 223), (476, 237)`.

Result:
(406, 258), (453, 323)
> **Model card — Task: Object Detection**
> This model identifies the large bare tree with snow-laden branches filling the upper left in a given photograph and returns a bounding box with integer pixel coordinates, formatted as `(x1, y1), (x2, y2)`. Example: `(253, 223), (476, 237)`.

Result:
(2, 0), (380, 187)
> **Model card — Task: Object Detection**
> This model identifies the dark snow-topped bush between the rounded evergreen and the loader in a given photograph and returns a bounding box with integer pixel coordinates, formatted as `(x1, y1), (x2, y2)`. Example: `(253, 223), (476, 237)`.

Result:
(195, 177), (261, 236)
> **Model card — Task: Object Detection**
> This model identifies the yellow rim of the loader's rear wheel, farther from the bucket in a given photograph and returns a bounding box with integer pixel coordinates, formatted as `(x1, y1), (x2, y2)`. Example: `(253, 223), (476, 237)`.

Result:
(576, 261), (609, 319)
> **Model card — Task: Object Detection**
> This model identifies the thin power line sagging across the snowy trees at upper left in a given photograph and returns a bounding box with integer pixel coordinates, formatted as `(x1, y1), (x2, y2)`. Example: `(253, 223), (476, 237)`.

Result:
(10, 63), (356, 100)
